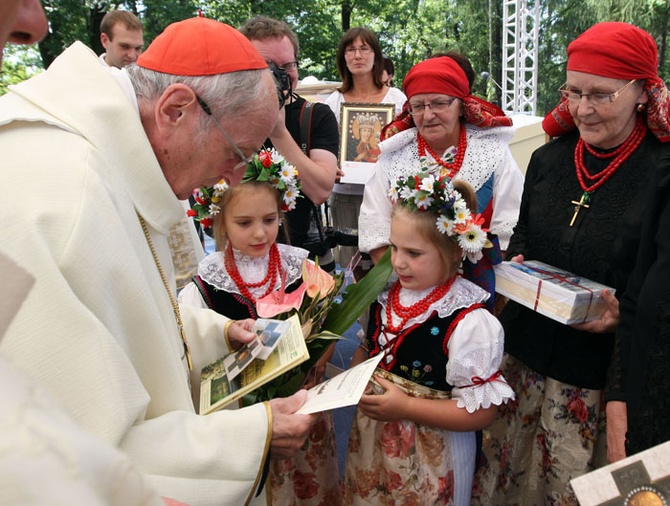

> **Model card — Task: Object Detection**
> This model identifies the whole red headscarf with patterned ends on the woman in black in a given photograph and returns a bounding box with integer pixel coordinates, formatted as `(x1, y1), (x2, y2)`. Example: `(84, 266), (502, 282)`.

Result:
(542, 21), (670, 142)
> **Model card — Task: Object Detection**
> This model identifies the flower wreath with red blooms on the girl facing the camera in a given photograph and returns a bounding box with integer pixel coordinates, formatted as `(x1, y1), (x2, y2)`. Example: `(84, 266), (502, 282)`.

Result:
(186, 148), (300, 228)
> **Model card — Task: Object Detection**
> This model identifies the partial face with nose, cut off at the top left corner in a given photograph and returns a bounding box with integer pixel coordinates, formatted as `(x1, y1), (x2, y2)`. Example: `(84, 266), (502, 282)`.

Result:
(0, 0), (48, 64)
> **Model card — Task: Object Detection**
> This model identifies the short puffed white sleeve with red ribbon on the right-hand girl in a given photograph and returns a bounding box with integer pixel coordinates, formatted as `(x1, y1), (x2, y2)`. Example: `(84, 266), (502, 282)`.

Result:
(447, 309), (514, 413)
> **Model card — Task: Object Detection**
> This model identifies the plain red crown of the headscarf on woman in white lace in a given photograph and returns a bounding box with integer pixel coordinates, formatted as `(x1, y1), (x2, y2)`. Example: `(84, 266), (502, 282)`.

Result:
(402, 56), (470, 99)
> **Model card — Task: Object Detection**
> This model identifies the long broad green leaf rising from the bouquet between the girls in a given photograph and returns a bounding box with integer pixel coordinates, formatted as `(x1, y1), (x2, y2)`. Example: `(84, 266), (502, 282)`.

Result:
(321, 248), (393, 335)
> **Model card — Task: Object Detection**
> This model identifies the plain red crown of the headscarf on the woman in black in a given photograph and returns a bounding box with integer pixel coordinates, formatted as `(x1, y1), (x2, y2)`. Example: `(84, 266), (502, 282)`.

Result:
(567, 21), (658, 80)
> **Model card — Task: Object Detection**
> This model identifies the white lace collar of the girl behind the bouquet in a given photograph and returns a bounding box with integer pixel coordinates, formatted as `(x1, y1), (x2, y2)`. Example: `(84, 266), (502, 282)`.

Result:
(198, 244), (309, 297)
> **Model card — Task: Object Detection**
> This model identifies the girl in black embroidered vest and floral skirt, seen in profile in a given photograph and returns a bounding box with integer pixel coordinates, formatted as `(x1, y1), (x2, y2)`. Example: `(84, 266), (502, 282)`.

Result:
(344, 172), (514, 505)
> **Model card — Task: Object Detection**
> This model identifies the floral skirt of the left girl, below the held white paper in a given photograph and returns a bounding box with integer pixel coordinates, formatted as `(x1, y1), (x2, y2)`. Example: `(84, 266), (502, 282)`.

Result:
(268, 411), (342, 506)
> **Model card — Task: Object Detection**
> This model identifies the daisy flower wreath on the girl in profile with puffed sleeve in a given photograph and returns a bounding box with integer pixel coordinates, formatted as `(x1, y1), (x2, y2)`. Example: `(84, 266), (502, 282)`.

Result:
(390, 171), (491, 263)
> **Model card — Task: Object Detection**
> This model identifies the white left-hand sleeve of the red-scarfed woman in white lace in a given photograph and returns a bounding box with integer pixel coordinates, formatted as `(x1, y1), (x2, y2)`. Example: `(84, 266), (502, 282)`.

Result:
(358, 158), (391, 253)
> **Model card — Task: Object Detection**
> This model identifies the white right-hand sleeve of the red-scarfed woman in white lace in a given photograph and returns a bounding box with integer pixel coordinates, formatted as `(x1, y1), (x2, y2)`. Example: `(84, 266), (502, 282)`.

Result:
(490, 148), (523, 251)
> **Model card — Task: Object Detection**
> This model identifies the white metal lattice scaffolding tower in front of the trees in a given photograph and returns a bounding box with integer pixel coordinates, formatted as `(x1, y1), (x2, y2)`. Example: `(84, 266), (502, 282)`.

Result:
(502, 0), (540, 115)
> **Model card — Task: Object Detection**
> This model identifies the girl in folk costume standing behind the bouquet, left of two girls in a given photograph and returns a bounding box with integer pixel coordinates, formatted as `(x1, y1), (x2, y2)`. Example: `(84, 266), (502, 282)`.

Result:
(179, 151), (341, 506)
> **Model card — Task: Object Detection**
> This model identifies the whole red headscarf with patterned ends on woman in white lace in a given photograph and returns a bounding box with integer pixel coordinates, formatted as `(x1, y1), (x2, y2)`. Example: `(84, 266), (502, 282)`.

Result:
(381, 56), (512, 140)
